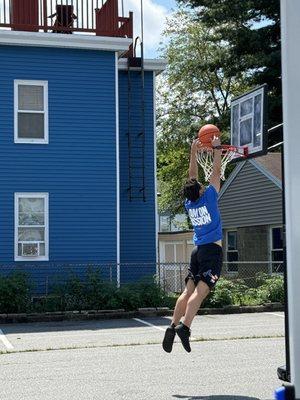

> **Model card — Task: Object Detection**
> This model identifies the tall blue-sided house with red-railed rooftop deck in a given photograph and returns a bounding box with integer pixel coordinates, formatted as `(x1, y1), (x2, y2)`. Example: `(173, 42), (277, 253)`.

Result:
(0, 0), (165, 288)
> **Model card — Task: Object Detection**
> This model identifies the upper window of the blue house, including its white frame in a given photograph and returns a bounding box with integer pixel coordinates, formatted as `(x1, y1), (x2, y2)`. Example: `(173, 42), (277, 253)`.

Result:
(14, 80), (48, 144)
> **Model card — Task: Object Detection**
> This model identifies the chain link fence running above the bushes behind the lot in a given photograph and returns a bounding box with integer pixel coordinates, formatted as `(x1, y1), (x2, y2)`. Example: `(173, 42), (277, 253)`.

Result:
(0, 261), (283, 296)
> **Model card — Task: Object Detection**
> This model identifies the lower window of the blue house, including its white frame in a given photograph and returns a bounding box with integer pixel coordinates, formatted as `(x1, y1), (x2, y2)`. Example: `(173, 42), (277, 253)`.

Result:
(15, 193), (48, 261)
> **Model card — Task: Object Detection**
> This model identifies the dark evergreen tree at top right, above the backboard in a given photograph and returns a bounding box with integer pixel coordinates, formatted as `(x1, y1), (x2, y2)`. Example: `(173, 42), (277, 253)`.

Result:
(178, 0), (282, 127)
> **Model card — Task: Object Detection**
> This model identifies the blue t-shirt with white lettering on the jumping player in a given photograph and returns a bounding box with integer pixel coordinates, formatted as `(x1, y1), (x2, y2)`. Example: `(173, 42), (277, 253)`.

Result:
(185, 185), (222, 246)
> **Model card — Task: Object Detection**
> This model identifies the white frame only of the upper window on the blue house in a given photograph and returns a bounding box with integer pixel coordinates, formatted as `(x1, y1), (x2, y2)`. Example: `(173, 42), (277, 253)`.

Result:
(14, 79), (49, 144)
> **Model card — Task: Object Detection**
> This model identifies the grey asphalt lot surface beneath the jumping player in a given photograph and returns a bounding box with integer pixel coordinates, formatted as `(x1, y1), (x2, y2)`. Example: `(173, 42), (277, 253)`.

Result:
(0, 312), (285, 400)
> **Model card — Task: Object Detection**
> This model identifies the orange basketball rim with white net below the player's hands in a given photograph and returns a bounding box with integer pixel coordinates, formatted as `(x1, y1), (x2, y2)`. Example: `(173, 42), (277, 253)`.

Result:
(197, 145), (248, 181)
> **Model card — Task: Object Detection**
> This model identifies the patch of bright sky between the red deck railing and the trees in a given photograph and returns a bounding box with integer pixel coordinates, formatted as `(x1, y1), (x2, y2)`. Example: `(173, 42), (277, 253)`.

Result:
(120, 0), (176, 58)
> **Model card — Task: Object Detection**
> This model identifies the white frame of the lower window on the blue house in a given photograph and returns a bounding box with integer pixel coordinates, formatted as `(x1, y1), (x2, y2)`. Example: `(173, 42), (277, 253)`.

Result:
(15, 192), (49, 261)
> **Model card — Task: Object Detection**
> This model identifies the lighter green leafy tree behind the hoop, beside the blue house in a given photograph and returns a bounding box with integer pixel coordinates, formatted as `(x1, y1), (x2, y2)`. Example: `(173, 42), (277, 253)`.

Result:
(157, 9), (248, 214)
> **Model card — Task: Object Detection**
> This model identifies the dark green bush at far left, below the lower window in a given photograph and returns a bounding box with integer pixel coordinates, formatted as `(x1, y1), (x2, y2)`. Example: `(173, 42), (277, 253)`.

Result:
(0, 272), (32, 313)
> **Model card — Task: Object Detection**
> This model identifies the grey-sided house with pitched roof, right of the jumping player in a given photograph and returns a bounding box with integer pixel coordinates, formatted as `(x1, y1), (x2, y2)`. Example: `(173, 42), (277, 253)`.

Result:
(219, 153), (283, 276)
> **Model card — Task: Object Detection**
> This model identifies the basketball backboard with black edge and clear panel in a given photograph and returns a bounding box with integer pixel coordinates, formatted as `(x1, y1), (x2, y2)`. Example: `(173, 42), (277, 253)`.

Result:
(231, 85), (268, 161)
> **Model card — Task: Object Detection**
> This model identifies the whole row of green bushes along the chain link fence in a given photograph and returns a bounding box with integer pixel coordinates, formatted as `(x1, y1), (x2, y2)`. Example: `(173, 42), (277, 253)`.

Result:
(0, 269), (284, 313)
